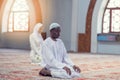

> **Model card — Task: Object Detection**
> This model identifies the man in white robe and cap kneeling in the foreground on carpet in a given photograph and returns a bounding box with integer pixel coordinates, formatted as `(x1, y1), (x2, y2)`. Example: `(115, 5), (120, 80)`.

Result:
(40, 23), (80, 78)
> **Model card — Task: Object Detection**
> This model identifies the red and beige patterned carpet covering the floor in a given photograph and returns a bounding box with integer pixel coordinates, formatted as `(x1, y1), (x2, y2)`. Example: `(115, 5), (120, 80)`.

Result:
(0, 49), (120, 80)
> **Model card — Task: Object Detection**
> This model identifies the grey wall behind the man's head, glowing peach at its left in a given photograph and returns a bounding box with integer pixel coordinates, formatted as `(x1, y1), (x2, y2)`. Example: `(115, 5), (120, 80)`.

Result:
(40, 0), (72, 51)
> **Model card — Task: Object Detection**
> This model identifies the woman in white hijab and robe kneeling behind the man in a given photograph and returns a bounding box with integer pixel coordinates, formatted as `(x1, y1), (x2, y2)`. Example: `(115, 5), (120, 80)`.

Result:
(29, 23), (43, 64)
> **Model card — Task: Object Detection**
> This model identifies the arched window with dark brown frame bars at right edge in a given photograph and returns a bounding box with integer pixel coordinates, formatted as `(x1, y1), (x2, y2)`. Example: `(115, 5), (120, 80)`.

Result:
(102, 0), (120, 33)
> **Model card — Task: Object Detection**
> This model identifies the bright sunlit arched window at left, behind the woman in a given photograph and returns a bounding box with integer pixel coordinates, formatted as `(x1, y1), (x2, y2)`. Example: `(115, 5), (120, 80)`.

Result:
(7, 0), (29, 32)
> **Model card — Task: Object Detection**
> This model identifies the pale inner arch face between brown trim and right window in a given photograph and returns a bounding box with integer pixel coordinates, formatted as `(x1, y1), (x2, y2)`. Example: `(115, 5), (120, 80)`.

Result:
(91, 0), (108, 53)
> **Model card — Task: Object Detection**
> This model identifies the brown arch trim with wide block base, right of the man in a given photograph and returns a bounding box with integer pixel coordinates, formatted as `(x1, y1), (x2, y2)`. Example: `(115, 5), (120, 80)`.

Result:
(78, 0), (96, 52)
